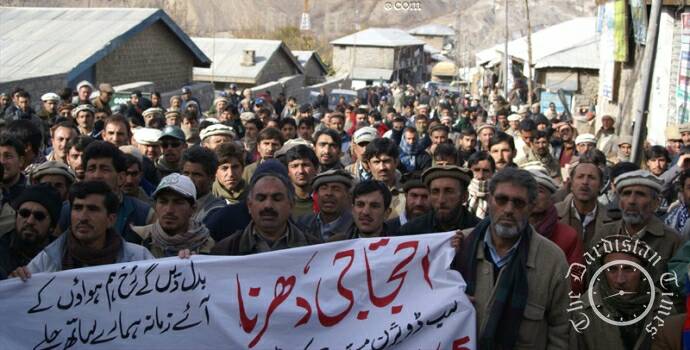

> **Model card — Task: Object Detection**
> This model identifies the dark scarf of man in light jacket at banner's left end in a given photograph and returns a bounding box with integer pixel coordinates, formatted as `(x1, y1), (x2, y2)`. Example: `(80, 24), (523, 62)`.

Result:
(62, 229), (124, 270)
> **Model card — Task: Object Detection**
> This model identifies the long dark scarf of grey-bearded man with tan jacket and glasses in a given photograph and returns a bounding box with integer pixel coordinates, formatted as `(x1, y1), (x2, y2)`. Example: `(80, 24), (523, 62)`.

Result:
(458, 217), (532, 350)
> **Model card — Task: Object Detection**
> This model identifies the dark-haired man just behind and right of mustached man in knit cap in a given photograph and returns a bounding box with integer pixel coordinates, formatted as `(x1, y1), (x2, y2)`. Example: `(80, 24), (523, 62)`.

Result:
(276, 141), (319, 218)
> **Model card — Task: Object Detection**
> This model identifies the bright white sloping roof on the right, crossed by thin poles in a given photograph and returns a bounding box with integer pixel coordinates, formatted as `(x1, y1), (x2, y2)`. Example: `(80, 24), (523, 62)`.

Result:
(475, 17), (599, 68)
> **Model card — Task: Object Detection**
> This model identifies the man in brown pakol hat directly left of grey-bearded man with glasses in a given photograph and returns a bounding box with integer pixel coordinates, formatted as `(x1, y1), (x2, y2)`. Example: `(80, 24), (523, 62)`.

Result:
(399, 165), (479, 235)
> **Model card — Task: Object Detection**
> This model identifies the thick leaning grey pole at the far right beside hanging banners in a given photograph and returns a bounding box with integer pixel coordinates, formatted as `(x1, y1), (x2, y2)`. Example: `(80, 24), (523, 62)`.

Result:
(630, 0), (661, 164)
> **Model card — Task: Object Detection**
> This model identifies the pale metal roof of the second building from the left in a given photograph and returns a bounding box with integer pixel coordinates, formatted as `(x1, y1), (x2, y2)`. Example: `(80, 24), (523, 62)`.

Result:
(192, 37), (303, 83)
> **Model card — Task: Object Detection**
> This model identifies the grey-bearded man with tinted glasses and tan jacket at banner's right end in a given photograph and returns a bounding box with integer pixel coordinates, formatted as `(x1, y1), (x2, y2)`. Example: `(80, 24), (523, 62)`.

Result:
(452, 168), (569, 349)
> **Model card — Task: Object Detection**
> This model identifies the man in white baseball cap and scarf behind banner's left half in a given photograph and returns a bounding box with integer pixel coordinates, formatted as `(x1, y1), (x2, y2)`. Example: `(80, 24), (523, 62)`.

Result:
(132, 173), (215, 258)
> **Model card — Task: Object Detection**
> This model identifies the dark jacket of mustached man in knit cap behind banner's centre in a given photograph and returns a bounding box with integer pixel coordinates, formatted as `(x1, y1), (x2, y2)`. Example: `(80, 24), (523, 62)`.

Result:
(211, 220), (323, 255)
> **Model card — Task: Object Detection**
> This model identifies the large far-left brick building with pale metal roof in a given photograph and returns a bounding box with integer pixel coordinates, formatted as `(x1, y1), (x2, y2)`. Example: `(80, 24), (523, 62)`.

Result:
(0, 7), (211, 99)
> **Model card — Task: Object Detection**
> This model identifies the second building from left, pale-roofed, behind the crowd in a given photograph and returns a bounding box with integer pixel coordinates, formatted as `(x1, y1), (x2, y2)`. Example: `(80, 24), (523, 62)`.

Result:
(192, 38), (304, 90)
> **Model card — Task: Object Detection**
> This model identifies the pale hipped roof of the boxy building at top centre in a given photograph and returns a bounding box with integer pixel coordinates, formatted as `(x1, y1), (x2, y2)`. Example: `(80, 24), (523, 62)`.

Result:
(331, 28), (424, 47)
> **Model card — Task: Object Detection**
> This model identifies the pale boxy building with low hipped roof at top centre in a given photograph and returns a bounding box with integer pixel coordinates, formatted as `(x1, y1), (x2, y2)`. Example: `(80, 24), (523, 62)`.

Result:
(331, 28), (426, 87)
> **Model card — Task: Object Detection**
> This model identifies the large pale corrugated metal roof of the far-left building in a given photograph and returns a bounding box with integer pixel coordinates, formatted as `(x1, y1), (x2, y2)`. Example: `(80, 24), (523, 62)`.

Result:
(0, 7), (211, 82)
